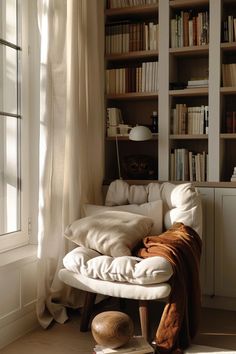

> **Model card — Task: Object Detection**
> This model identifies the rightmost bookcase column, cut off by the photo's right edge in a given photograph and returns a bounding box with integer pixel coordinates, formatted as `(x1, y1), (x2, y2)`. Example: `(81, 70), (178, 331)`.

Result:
(220, 0), (236, 181)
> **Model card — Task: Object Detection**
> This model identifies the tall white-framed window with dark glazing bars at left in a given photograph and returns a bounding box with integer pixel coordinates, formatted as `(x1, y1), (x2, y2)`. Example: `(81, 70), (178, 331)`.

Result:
(0, 0), (28, 251)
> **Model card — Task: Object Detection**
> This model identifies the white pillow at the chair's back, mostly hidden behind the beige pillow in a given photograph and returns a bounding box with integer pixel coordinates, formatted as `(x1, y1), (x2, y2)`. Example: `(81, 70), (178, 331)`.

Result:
(83, 200), (163, 235)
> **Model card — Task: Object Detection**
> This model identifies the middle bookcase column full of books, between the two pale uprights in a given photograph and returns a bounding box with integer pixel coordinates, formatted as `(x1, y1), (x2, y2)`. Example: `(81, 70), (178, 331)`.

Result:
(169, 1), (209, 182)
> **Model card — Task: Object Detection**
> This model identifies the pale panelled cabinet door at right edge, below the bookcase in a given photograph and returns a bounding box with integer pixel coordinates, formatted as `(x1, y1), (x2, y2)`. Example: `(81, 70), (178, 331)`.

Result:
(215, 188), (236, 298)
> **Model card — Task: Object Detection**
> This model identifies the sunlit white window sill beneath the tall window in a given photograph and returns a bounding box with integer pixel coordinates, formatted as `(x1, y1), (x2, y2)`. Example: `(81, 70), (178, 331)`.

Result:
(0, 245), (37, 268)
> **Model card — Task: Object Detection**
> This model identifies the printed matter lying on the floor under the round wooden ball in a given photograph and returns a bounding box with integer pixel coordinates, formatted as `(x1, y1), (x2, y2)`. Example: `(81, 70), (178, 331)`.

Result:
(93, 336), (154, 354)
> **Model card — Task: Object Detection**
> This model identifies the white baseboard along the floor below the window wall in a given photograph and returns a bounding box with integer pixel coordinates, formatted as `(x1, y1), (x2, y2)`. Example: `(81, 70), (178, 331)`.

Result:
(0, 309), (39, 349)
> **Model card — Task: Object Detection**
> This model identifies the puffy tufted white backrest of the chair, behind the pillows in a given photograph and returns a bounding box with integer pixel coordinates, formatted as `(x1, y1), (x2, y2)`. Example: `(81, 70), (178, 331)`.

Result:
(105, 180), (202, 237)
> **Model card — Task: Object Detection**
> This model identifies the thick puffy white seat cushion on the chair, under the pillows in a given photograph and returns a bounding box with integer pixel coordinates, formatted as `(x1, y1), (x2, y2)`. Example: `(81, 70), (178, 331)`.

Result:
(63, 247), (173, 285)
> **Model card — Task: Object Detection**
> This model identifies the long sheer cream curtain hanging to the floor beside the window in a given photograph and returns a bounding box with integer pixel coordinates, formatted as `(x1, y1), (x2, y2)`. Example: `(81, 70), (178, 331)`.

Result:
(37, 0), (104, 328)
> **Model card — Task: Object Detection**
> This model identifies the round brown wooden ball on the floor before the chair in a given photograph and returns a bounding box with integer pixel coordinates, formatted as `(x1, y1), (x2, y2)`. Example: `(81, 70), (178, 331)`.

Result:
(91, 311), (134, 349)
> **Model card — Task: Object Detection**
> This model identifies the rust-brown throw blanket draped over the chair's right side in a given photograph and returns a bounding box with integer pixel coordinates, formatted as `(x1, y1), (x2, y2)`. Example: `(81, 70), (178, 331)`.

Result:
(135, 223), (202, 353)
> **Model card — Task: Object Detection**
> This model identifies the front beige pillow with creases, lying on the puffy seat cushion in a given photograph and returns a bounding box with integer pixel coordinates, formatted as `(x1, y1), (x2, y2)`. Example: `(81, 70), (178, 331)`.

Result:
(65, 211), (153, 257)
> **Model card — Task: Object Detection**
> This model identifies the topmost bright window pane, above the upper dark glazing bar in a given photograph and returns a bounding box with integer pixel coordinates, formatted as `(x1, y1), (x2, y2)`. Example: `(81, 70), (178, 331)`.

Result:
(0, 0), (17, 44)
